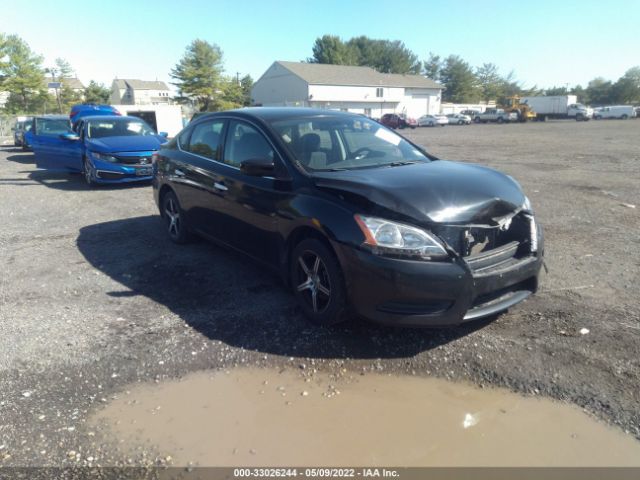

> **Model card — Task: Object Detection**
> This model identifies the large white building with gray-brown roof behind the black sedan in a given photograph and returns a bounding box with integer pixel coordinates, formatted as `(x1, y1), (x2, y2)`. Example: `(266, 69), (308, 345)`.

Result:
(251, 62), (444, 118)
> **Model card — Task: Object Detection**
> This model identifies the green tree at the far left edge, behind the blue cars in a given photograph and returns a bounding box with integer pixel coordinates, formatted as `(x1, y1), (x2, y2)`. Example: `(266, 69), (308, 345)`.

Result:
(0, 34), (48, 113)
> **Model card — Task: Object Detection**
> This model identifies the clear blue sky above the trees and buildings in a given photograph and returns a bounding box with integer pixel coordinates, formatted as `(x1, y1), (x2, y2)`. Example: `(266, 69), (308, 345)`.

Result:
(0, 0), (640, 91)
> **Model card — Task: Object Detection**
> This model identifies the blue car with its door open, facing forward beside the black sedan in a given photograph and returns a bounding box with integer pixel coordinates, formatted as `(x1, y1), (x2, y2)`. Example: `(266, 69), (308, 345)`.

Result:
(30, 115), (166, 185)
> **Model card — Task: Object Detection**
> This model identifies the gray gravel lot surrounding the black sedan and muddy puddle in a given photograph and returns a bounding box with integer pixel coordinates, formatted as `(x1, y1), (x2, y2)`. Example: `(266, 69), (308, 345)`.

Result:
(0, 120), (640, 466)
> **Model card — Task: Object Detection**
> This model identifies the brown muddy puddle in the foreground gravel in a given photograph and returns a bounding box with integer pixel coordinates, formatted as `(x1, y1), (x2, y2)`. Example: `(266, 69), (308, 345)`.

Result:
(92, 369), (640, 466)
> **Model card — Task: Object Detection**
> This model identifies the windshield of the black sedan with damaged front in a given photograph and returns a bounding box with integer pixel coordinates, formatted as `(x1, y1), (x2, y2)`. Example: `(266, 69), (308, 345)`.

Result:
(271, 116), (429, 172)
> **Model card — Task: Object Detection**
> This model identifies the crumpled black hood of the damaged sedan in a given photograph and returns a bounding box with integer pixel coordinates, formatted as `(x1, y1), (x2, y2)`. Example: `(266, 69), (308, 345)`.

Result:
(314, 160), (525, 225)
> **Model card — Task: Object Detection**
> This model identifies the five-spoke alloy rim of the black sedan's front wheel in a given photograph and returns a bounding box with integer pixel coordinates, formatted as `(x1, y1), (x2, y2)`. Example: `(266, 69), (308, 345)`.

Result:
(296, 250), (331, 313)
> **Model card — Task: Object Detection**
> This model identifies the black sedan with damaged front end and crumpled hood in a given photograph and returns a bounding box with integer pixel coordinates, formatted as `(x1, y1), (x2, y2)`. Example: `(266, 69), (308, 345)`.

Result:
(153, 108), (543, 326)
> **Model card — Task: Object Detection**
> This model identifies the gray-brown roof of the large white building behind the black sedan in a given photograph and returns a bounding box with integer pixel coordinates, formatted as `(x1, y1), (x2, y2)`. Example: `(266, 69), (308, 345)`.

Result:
(276, 61), (444, 89)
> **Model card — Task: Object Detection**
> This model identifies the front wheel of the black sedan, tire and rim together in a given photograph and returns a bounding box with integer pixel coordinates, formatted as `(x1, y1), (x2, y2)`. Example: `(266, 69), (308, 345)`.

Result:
(289, 238), (347, 326)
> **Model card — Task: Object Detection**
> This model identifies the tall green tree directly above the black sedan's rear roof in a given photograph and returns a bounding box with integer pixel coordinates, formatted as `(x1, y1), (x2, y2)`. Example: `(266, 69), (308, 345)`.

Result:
(170, 39), (225, 112)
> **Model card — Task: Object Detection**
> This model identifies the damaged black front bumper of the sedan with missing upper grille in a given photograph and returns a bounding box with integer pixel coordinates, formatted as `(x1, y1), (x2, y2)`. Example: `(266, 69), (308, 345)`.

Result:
(333, 228), (544, 327)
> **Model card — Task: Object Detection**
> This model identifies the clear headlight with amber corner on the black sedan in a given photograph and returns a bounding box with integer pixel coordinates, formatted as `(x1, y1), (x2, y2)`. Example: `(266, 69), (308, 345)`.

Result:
(355, 215), (448, 260)
